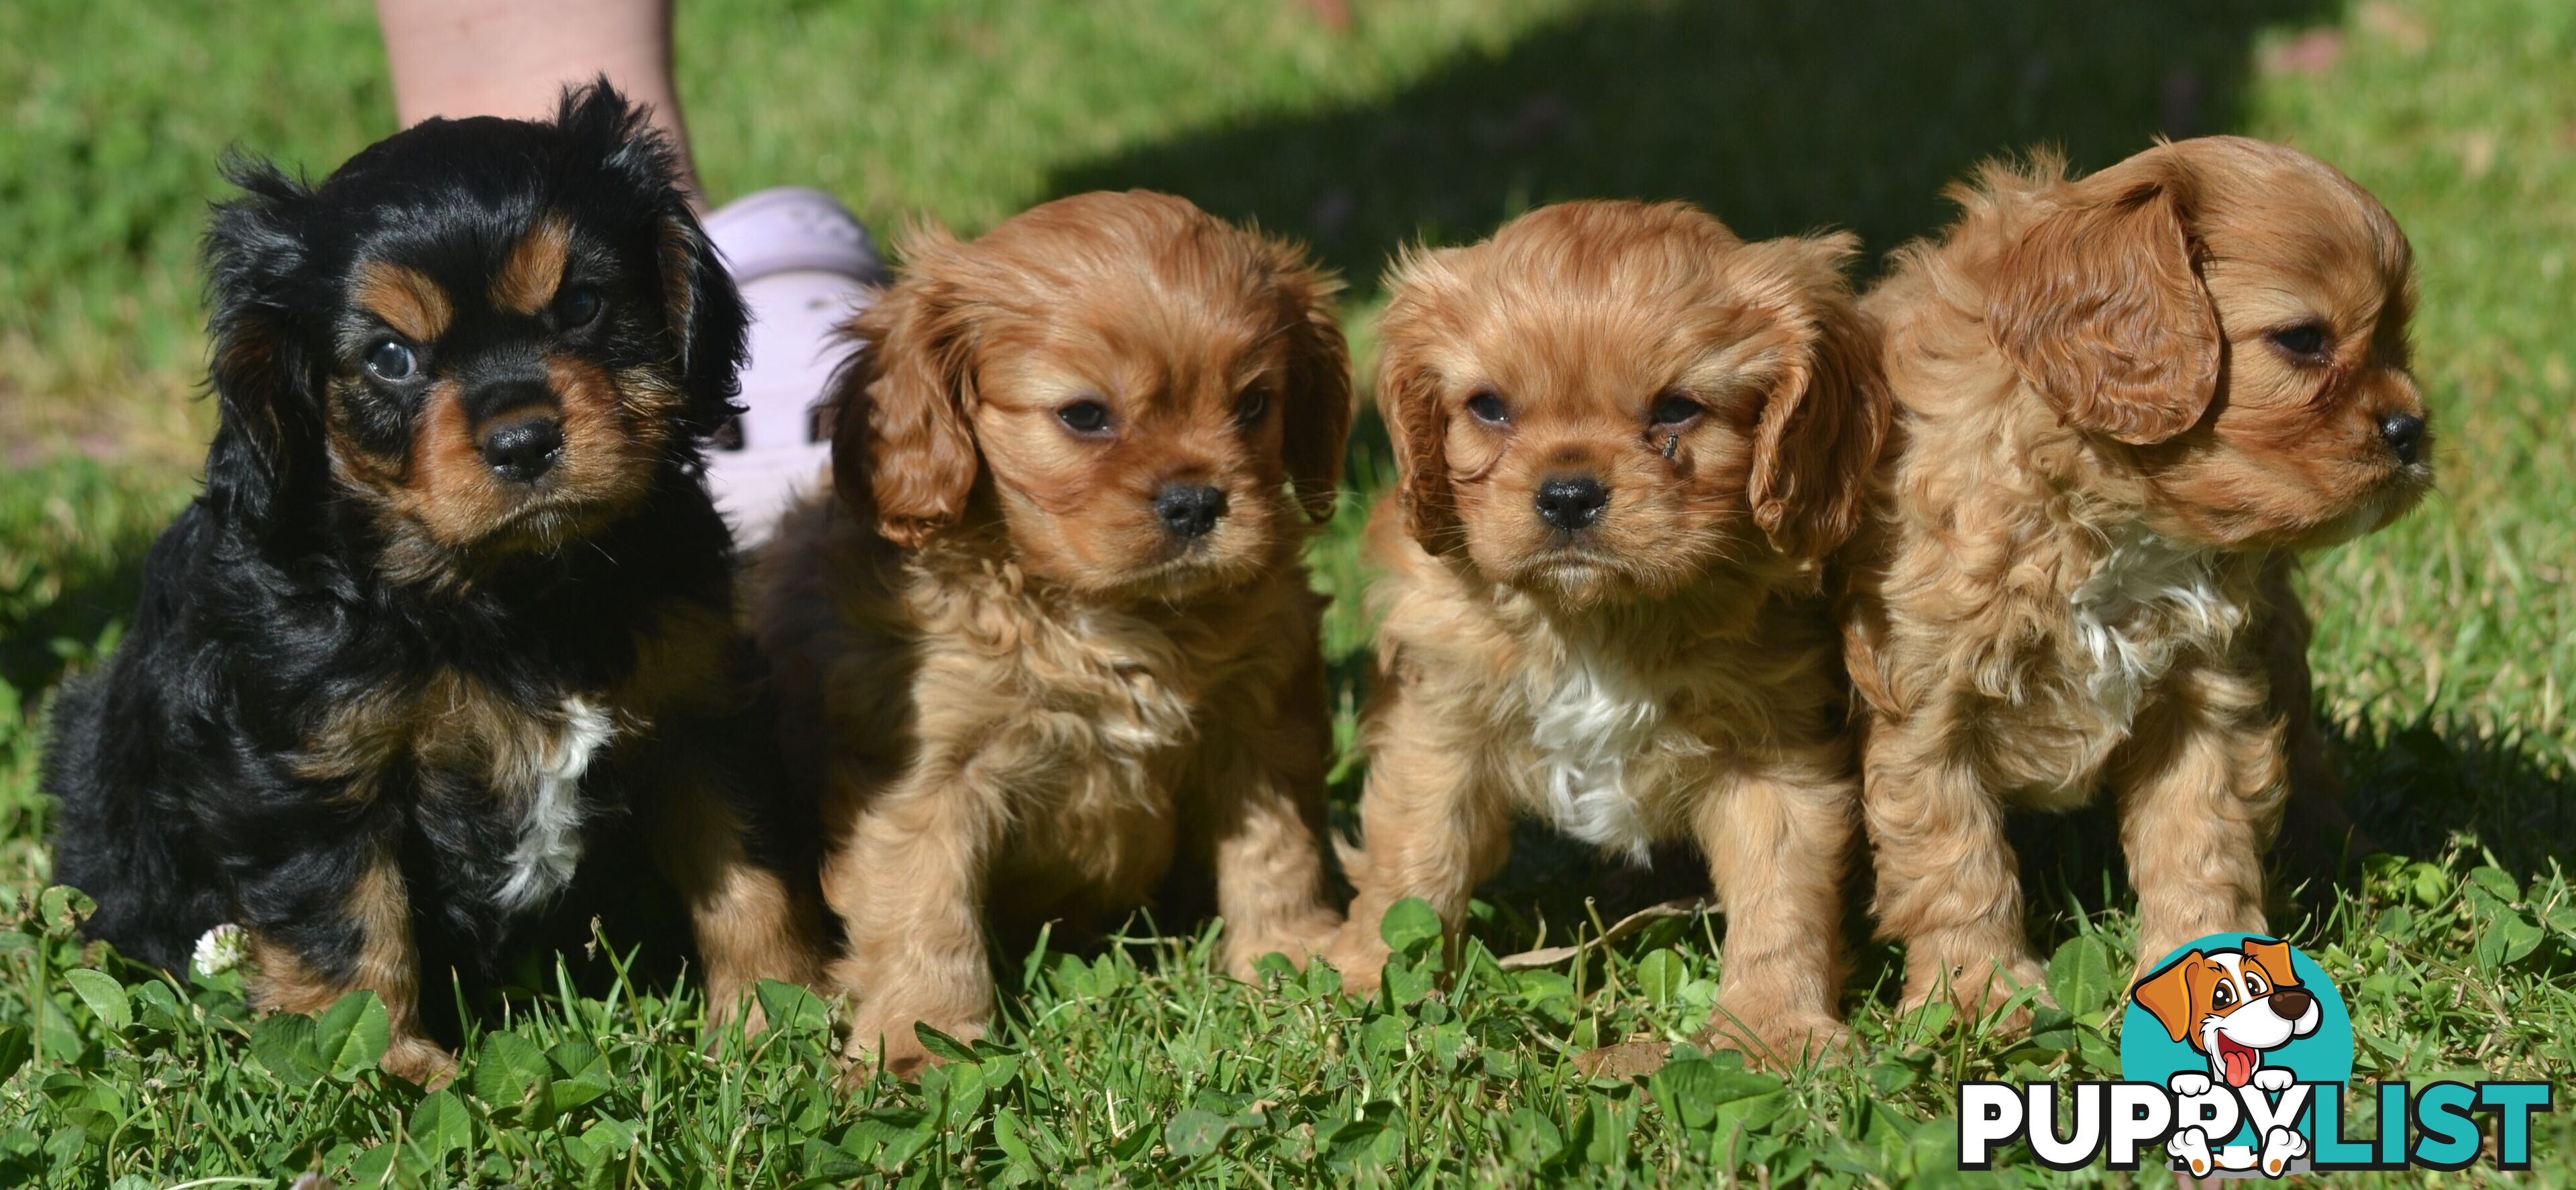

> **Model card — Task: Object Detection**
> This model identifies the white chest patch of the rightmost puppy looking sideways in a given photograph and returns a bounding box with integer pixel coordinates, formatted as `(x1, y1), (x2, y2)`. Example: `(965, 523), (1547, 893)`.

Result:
(2069, 531), (2244, 732)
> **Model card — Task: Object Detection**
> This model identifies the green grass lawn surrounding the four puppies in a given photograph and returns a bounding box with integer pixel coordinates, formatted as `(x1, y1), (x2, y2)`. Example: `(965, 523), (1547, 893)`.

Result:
(0, 0), (2576, 1187)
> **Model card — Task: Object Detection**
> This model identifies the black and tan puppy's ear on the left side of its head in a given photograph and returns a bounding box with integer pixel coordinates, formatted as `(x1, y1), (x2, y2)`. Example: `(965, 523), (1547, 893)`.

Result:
(203, 157), (325, 528)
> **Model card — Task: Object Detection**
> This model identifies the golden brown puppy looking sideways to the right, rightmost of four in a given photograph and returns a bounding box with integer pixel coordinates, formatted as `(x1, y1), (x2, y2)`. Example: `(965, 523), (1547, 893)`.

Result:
(1847, 137), (2432, 1010)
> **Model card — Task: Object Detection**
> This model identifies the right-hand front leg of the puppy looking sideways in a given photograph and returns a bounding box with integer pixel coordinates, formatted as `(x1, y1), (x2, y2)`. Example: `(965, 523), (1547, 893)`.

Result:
(2110, 672), (2288, 973)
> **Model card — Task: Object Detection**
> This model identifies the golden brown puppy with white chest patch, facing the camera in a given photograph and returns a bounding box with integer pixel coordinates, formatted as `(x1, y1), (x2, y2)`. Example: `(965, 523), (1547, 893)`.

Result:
(1329, 203), (1888, 1059)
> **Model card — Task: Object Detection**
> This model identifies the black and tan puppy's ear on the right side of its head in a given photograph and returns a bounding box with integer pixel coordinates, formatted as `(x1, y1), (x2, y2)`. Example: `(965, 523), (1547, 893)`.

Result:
(554, 74), (749, 435)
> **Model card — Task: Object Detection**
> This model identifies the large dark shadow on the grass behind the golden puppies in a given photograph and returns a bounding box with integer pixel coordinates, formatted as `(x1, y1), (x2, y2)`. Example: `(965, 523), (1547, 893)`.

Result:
(1051, 0), (2342, 294)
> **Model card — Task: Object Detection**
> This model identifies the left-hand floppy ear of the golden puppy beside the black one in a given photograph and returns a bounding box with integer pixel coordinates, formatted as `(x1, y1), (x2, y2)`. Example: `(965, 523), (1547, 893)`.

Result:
(832, 229), (979, 549)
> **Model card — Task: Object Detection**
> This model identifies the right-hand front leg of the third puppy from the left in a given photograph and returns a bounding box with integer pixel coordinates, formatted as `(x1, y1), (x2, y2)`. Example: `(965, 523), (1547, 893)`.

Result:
(1693, 757), (1860, 1067)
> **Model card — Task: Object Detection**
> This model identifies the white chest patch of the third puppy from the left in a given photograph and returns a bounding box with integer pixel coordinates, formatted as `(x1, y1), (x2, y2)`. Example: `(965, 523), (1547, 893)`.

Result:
(1530, 644), (1664, 863)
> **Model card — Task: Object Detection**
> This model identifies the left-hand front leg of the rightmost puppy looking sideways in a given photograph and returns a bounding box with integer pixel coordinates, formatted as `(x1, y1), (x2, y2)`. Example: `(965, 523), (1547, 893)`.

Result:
(1862, 721), (2043, 1012)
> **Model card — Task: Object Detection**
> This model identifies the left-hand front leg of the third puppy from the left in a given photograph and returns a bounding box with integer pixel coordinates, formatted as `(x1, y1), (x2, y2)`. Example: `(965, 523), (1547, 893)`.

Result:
(1324, 693), (1512, 994)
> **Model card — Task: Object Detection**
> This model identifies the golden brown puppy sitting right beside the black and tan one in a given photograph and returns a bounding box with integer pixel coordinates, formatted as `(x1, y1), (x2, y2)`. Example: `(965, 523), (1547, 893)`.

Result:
(755, 191), (1350, 1069)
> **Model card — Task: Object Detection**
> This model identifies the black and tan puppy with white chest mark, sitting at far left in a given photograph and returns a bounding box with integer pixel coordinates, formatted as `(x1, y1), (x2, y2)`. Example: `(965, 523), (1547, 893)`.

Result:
(46, 83), (816, 1079)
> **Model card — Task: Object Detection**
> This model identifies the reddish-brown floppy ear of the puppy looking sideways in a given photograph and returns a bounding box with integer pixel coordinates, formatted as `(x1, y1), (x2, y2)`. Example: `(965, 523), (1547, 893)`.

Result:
(1986, 147), (2223, 445)
